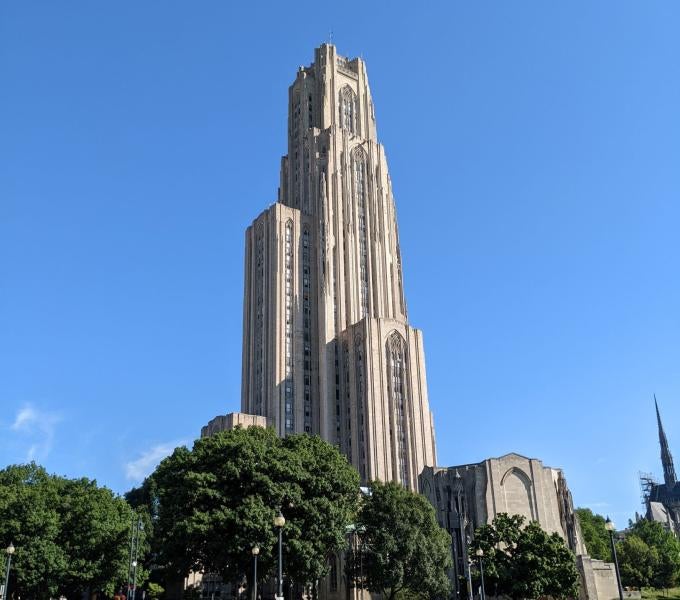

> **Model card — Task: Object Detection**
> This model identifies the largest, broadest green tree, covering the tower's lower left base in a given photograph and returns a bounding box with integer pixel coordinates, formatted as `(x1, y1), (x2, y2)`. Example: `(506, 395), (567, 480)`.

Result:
(147, 427), (359, 583)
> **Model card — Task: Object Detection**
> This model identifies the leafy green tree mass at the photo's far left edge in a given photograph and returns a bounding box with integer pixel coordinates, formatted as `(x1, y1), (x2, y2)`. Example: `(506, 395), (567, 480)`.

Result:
(0, 463), (145, 598)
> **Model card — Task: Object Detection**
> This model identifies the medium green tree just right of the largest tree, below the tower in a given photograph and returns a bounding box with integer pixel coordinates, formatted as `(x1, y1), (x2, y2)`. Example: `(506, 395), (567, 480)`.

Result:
(353, 481), (451, 600)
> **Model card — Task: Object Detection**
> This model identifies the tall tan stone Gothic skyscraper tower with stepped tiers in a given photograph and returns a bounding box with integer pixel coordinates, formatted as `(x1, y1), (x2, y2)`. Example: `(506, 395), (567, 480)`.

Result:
(241, 44), (436, 490)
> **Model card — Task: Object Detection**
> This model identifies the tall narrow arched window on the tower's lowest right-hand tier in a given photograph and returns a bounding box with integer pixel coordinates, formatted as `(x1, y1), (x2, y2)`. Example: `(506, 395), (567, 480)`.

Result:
(385, 331), (410, 487)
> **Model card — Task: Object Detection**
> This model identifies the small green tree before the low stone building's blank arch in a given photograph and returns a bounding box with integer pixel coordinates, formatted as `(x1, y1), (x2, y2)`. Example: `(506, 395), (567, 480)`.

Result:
(471, 513), (579, 598)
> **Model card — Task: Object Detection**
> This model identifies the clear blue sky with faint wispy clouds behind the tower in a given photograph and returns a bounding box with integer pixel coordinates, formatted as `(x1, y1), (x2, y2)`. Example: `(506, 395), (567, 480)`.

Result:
(0, 0), (680, 524)
